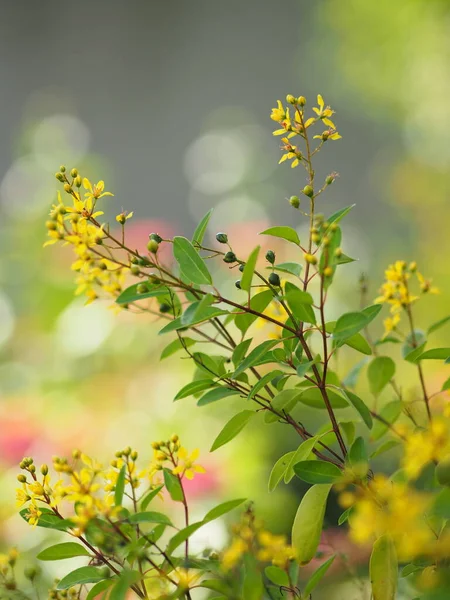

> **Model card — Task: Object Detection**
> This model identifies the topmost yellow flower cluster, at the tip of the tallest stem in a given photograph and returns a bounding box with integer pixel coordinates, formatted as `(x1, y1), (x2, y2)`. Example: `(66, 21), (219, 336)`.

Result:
(270, 94), (341, 168)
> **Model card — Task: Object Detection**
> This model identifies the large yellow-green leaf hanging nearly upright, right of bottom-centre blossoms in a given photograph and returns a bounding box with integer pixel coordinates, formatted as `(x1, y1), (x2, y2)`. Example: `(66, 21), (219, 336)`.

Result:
(292, 485), (331, 565)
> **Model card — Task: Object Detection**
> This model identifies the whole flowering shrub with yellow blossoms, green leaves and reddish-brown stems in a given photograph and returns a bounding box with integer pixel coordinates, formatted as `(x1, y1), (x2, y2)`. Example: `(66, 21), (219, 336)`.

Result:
(9, 95), (450, 600)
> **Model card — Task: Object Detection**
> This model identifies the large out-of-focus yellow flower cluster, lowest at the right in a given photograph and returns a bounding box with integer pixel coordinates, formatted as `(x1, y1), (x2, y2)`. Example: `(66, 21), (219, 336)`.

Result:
(339, 474), (435, 560)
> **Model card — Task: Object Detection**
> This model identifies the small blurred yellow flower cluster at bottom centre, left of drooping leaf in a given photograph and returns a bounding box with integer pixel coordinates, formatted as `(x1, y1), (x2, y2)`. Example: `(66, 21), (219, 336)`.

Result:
(221, 508), (295, 571)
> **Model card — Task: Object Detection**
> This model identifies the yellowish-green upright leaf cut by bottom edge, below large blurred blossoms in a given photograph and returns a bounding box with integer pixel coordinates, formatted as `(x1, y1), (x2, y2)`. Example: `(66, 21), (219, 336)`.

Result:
(369, 535), (398, 600)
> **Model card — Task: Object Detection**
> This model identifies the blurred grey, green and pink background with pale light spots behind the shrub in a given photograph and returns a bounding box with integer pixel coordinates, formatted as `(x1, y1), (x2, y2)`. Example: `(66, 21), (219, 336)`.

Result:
(0, 0), (450, 597)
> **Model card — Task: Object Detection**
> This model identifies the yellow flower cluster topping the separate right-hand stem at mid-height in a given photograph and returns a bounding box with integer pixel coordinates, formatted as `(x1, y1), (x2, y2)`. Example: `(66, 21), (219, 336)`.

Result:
(375, 260), (439, 335)
